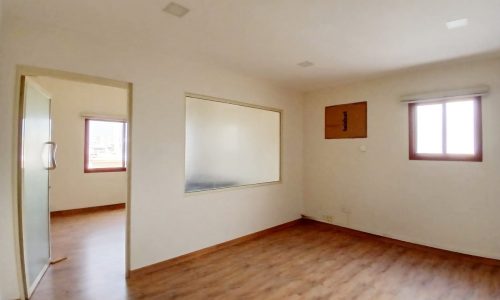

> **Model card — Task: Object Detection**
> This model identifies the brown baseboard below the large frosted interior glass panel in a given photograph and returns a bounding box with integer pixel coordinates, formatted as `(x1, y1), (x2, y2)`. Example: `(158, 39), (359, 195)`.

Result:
(129, 219), (302, 280)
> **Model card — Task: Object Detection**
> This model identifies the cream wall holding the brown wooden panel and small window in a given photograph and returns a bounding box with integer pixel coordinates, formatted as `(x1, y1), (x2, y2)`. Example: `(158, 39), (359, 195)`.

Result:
(304, 59), (500, 259)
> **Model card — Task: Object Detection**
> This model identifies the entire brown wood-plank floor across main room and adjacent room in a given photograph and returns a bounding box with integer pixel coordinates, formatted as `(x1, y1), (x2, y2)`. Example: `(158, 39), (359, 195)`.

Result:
(34, 212), (500, 300)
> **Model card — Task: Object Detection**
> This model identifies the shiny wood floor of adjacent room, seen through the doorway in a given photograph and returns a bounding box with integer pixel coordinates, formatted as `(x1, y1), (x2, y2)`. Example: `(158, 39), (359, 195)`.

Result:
(31, 209), (128, 300)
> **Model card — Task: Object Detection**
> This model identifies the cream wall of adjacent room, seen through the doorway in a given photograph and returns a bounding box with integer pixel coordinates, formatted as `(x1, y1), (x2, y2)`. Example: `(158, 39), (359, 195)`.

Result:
(32, 77), (128, 211)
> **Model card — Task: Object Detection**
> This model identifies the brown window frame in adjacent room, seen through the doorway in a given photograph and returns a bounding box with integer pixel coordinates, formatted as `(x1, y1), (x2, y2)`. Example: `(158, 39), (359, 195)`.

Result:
(83, 117), (128, 173)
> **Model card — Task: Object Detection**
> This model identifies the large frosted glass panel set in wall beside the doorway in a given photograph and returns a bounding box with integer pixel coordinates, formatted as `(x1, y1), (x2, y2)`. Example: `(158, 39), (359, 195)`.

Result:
(185, 97), (281, 192)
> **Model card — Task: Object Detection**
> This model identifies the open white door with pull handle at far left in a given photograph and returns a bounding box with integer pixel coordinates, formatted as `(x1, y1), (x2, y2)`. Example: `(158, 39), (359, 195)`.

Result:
(20, 77), (55, 298)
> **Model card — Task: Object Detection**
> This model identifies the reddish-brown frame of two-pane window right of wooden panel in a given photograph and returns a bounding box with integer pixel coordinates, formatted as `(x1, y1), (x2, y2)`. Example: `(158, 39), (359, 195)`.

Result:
(408, 96), (483, 162)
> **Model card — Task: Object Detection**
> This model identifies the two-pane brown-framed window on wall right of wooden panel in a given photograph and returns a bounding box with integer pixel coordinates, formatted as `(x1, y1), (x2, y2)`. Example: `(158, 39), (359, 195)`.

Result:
(409, 97), (483, 161)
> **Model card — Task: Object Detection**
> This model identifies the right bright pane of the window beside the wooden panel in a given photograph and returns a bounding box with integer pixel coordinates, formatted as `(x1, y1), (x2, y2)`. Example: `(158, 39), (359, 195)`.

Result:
(446, 100), (474, 154)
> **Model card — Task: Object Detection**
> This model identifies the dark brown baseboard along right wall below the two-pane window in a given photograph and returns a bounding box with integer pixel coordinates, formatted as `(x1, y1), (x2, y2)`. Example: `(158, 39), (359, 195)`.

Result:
(302, 215), (500, 266)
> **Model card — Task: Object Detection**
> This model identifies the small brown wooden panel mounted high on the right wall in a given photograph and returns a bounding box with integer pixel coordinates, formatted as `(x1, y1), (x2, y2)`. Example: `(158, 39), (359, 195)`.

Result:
(325, 101), (367, 139)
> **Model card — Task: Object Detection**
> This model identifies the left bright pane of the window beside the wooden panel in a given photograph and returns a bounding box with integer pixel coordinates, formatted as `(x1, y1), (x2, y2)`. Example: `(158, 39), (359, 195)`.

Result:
(417, 104), (443, 154)
